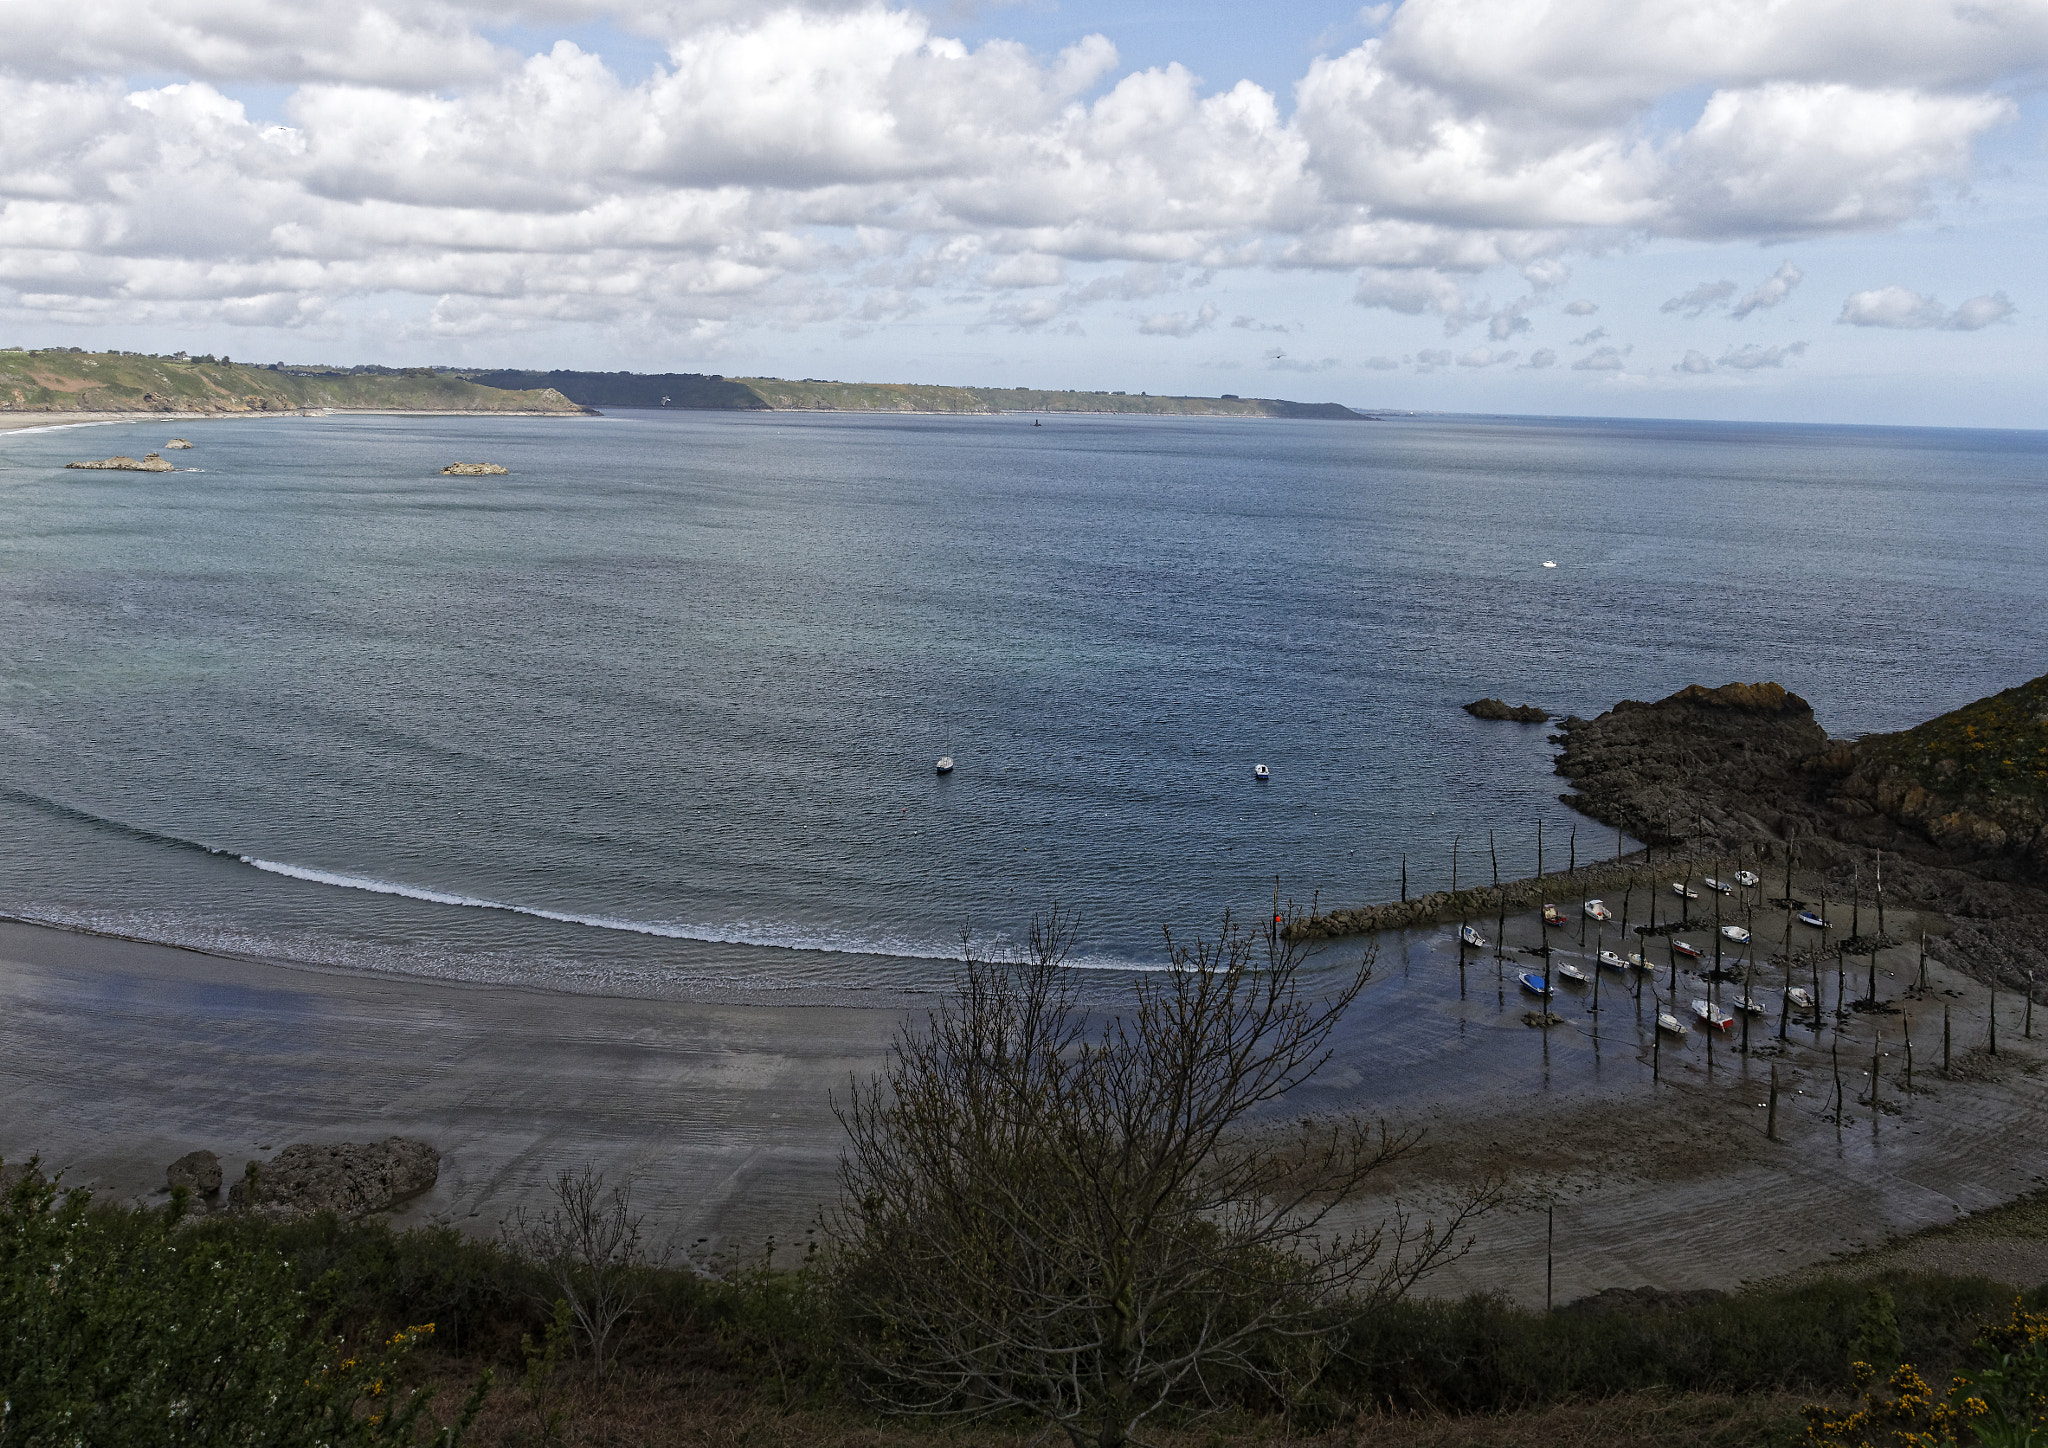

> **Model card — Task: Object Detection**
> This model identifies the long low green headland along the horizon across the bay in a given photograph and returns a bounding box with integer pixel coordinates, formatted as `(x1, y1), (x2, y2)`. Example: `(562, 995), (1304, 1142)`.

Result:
(0, 346), (1372, 422)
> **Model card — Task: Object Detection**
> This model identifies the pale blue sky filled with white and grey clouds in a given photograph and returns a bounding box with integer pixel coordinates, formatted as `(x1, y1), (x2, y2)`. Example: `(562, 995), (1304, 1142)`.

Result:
(0, 0), (2048, 428)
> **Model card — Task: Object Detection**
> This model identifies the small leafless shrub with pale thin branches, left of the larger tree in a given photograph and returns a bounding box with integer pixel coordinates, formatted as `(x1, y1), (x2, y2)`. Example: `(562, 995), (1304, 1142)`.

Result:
(508, 1165), (655, 1378)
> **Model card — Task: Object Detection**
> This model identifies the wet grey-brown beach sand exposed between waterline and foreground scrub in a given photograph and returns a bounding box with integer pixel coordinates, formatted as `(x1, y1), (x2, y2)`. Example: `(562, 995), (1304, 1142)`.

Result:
(0, 897), (2048, 1305)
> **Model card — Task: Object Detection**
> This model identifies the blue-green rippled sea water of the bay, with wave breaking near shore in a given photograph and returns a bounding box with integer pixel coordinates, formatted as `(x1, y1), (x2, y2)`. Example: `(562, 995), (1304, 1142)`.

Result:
(0, 414), (2048, 997)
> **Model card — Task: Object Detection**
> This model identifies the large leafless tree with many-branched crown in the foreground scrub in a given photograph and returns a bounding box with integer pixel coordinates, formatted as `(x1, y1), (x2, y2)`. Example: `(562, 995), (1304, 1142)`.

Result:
(831, 907), (1491, 1448)
